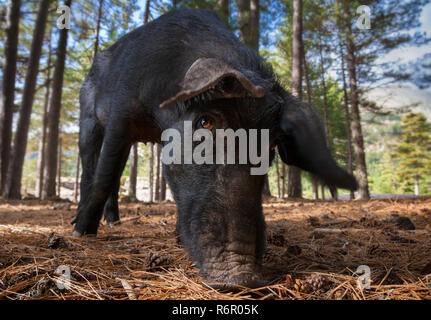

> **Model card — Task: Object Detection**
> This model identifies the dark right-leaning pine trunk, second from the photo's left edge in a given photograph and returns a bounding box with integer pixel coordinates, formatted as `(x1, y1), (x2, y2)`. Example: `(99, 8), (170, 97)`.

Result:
(3, 0), (49, 199)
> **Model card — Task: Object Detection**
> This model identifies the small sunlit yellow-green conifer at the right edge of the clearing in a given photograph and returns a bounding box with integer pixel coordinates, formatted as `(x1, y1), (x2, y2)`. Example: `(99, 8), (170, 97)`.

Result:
(395, 113), (431, 196)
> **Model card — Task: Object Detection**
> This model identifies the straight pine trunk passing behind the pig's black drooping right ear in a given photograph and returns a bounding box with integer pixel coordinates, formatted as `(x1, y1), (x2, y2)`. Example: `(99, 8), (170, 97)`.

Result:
(287, 0), (303, 198)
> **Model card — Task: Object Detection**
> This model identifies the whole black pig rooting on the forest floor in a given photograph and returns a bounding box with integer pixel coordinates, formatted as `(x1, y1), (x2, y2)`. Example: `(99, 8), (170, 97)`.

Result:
(73, 10), (357, 287)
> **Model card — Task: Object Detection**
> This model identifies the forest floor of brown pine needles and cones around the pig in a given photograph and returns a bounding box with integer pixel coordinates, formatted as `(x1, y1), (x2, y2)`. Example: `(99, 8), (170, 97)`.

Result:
(0, 197), (431, 300)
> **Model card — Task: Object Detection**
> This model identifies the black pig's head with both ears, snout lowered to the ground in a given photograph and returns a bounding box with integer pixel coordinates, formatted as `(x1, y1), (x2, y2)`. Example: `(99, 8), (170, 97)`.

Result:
(156, 58), (357, 287)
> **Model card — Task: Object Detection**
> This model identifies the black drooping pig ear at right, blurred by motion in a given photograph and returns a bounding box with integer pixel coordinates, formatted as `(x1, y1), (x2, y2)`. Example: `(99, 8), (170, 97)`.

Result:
(277, 97), (358, 190)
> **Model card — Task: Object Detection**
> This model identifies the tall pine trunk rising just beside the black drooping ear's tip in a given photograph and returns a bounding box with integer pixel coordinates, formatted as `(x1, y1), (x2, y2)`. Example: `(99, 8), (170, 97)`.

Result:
(344, 1), (370, 200)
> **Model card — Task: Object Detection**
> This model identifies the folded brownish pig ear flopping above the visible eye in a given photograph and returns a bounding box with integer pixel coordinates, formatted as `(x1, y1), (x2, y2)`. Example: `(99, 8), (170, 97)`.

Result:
(160, 58), (265, 108)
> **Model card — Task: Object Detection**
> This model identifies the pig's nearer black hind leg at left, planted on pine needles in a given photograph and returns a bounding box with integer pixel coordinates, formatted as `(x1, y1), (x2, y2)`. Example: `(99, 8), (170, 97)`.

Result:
(73, 119), (131, 237)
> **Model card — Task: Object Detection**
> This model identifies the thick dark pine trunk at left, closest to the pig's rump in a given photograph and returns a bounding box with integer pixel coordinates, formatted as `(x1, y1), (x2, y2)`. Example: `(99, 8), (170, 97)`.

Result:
(42, 0), (72, 199)
